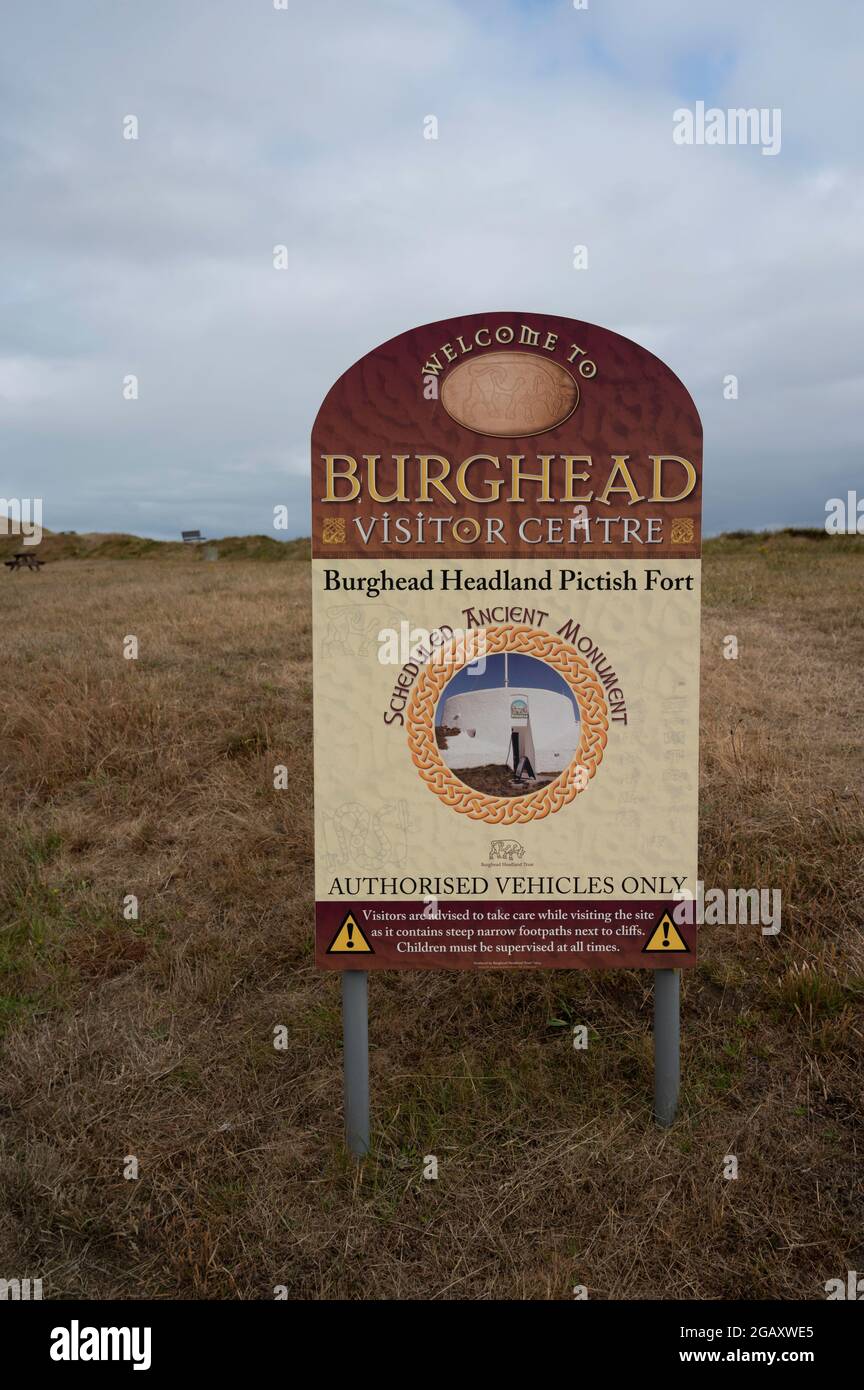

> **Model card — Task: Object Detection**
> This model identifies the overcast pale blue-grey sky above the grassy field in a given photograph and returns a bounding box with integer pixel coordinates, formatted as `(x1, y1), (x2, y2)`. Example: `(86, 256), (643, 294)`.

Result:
(0, 0), (864, 537)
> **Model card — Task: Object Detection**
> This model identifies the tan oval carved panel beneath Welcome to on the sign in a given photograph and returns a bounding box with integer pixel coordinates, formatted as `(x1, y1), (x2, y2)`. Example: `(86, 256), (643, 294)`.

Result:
(440, 352), (579, 435)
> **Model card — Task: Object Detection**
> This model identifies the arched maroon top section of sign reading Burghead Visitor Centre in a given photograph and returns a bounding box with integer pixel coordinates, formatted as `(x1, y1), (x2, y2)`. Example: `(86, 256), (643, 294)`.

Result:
(311, 311), (701, 560)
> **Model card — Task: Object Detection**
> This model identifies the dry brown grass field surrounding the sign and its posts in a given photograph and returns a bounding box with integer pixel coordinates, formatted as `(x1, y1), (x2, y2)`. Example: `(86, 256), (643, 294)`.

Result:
(0, 535), (864, 1300)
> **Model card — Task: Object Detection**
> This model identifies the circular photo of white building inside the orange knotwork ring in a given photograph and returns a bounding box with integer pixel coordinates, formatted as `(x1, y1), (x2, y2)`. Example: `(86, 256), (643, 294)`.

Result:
(435, 652), (582, 796)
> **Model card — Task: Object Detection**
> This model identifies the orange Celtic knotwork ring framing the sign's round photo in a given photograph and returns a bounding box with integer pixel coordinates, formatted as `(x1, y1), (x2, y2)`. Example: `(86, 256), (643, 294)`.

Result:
(407, 624), (608, 826)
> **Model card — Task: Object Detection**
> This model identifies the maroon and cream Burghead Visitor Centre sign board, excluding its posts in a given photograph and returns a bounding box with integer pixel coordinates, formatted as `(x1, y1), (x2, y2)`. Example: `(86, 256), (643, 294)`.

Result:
(311, 313), (701, 970)
